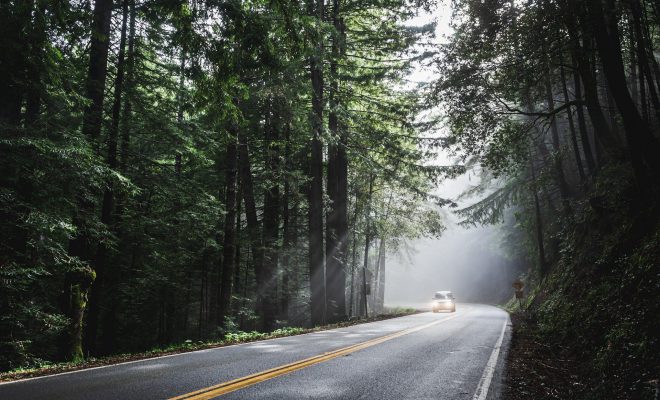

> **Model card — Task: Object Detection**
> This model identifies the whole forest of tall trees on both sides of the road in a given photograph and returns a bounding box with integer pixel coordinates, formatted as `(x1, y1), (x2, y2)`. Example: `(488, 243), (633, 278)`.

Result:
(0, 0), (660, 398)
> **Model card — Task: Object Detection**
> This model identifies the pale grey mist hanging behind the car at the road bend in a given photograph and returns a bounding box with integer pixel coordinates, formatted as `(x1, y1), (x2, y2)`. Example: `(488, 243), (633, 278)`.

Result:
(385, 162), (519, 307)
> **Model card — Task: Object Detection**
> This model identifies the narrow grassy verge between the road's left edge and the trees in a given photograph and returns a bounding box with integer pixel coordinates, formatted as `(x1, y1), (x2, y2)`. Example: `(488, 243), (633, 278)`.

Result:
(0, 308), (422, 382)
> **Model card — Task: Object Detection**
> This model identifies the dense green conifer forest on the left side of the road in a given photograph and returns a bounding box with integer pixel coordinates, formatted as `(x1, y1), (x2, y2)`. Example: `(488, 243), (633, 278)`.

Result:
(0, 0), (448, 370)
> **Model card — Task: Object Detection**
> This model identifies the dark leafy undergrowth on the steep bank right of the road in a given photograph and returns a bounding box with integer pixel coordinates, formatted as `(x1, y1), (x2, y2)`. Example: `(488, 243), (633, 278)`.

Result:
(507, 175), (660, 399)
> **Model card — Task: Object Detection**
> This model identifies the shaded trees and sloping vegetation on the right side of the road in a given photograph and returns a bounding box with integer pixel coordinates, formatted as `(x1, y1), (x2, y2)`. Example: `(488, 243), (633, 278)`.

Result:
(434, 0), (660, 399)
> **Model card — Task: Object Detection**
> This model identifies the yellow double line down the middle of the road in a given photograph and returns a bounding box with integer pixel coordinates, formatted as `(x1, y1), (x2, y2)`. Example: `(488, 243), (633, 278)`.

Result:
(170, 314), (458, 400)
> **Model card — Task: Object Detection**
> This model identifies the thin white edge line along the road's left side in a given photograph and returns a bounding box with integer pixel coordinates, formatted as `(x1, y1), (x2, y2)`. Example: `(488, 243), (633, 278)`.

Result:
(0, 313), (444, 386)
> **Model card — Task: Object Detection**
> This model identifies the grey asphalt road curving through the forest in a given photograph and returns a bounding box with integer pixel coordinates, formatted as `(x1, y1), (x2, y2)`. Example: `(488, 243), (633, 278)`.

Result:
(0, 304), (509, 400)
